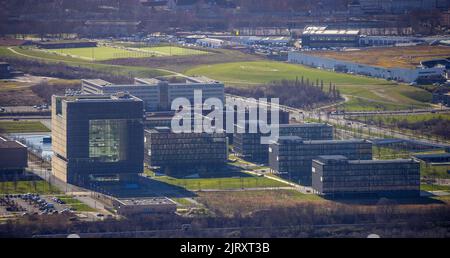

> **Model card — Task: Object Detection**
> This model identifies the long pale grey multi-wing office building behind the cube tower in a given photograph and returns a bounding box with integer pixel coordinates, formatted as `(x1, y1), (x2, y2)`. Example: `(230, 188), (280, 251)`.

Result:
(81, 77), (225, 111)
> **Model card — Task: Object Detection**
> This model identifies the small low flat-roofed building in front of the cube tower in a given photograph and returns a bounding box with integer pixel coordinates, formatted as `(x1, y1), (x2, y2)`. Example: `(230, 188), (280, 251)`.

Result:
(113, 197), (177, 217)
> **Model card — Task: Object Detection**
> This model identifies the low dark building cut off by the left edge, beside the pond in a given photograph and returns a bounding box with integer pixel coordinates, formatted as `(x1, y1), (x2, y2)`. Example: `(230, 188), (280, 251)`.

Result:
(0, 137), (28, 177)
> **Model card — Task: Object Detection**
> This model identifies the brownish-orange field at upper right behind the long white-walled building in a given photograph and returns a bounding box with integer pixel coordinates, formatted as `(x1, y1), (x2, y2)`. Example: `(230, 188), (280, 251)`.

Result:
(310, 46), (450, 68)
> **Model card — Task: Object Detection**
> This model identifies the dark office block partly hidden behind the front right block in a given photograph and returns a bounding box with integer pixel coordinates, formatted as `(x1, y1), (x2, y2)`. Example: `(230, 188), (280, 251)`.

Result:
(269, 136), (372, 185)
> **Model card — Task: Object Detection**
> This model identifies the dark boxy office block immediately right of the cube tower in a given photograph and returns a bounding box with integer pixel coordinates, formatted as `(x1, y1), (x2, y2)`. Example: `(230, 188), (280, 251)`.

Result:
(144, 127), (228, 174)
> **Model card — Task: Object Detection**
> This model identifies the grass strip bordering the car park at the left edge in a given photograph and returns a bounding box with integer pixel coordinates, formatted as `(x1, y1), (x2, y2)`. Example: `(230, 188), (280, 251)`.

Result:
(0, 180), (60, 194)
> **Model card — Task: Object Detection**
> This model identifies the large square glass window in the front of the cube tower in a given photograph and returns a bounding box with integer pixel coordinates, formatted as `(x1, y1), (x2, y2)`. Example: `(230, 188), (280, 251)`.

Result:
(89, 119), (128, 162)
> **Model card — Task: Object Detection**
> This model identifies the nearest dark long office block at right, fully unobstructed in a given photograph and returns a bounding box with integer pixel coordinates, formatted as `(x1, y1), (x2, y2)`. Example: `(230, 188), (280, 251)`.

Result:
(312, 155), (420, 197)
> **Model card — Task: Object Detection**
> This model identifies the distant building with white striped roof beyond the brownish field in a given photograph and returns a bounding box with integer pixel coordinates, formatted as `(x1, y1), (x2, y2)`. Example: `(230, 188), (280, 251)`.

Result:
(301, 26), (360, 48)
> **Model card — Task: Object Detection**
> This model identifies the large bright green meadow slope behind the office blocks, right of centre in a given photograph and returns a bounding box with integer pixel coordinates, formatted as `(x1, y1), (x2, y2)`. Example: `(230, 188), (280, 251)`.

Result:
(185, 61), (431, 111)
